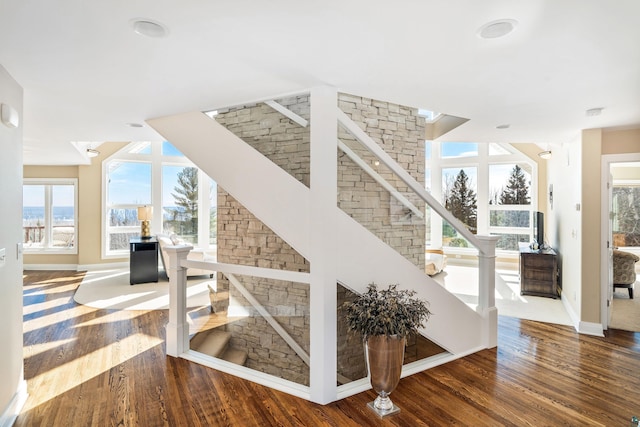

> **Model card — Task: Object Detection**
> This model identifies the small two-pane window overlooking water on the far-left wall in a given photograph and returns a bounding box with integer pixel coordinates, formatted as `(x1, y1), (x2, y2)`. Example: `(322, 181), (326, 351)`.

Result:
(22, 178), (78, 254)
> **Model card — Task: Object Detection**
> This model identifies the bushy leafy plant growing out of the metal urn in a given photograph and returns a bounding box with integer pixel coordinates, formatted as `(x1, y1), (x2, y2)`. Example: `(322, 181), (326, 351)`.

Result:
(345, 283), (432, 340)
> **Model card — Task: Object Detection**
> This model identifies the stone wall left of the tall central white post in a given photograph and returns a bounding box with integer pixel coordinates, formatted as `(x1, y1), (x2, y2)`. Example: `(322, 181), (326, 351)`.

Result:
(215, 95), (310, 385)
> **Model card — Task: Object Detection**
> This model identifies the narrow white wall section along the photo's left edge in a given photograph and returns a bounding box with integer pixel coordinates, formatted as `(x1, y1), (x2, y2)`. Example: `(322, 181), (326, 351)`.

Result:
(0, 65), (26, 425)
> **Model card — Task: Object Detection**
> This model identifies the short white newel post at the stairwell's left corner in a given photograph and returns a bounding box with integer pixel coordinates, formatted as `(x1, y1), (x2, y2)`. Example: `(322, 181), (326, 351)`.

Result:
(166, 246), (193, 357)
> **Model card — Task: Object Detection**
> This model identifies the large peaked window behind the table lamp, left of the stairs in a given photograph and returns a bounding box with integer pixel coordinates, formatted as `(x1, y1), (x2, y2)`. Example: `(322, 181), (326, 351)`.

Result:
(103, 141), (216, 258)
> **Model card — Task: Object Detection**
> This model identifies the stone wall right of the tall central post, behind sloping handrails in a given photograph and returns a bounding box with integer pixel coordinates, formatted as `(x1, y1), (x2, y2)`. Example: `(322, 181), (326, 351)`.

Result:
(338, 94), (426, 269)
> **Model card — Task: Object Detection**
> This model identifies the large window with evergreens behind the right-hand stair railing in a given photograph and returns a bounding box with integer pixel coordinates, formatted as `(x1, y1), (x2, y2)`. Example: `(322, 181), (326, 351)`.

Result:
(425, 141), (537, 251)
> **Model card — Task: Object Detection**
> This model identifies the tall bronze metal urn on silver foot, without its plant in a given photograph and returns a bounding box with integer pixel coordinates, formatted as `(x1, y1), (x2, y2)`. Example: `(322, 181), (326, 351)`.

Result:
(366, 335), (406, 417)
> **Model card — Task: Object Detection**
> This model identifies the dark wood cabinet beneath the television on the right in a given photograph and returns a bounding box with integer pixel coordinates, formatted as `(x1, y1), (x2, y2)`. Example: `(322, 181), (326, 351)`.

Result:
(520, 246), (558, 298)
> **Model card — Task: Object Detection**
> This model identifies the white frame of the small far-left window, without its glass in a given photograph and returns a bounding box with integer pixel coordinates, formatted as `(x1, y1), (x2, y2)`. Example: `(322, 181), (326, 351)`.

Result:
(22, 178), (78, 255)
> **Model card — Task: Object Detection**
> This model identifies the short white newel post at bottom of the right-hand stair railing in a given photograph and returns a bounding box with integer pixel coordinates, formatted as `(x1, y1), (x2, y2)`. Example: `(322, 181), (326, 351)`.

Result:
(476, 236), (499, 348)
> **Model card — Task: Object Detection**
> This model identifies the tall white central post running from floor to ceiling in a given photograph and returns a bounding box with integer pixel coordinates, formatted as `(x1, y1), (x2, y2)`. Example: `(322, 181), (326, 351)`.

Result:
(309, 86), (338, 404)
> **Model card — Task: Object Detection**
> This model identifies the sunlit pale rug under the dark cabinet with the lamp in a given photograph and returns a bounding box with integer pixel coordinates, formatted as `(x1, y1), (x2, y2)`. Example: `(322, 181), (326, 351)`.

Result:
(73, 269), (215, 310)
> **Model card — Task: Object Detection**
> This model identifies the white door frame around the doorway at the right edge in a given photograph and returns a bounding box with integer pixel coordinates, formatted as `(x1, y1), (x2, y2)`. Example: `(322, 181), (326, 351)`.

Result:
(600, 153), (640, 330)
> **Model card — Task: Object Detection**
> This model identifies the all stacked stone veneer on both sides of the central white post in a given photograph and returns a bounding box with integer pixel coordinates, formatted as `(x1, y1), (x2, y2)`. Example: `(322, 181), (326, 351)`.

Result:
(215, 94), (425, 385)
